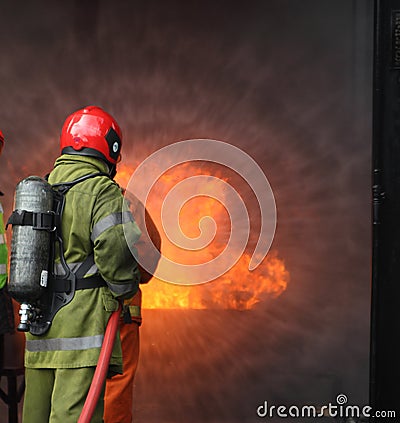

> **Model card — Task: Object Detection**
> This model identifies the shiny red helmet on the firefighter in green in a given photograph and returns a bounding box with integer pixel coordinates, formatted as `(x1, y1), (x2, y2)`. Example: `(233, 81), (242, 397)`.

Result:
(60, 106), (122, 165)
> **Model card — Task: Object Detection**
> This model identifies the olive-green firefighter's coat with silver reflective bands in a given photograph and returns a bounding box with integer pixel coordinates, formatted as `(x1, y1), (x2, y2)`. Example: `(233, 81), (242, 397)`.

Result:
(25, 155), (140, 373)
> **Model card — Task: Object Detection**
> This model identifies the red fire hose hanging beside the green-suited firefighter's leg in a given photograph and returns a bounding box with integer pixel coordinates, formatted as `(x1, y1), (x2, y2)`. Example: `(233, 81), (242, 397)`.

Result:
(78, 305), (121, 423)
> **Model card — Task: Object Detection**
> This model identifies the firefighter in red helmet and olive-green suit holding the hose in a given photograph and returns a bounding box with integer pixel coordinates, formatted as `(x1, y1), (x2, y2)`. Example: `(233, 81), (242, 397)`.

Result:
(23, 106), (140, 423)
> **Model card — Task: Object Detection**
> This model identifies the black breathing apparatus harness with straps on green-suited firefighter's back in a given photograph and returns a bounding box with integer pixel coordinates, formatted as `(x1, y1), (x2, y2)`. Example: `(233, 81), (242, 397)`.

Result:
(7, 172), (110, 335)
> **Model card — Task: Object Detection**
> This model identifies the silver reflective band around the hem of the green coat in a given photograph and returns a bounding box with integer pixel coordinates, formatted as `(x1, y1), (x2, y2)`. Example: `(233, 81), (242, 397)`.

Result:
(26, 335), (104, 352)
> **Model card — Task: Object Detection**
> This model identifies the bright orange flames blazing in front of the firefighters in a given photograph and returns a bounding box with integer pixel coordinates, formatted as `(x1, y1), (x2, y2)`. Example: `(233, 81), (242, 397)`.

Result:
(116, 163), (289, 310)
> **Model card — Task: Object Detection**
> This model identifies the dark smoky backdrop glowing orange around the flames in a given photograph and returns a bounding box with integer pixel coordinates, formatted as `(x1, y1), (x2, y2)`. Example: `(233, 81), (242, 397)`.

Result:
(0, 0), (373, 423)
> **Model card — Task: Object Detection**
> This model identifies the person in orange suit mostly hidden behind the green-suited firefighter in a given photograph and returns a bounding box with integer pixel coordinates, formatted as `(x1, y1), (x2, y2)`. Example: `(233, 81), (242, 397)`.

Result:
(104, 192), (161, 423)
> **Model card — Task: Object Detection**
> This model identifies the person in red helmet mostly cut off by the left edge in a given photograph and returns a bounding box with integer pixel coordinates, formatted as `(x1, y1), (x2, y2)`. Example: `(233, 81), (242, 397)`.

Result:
(0, 131), (14, 367)
